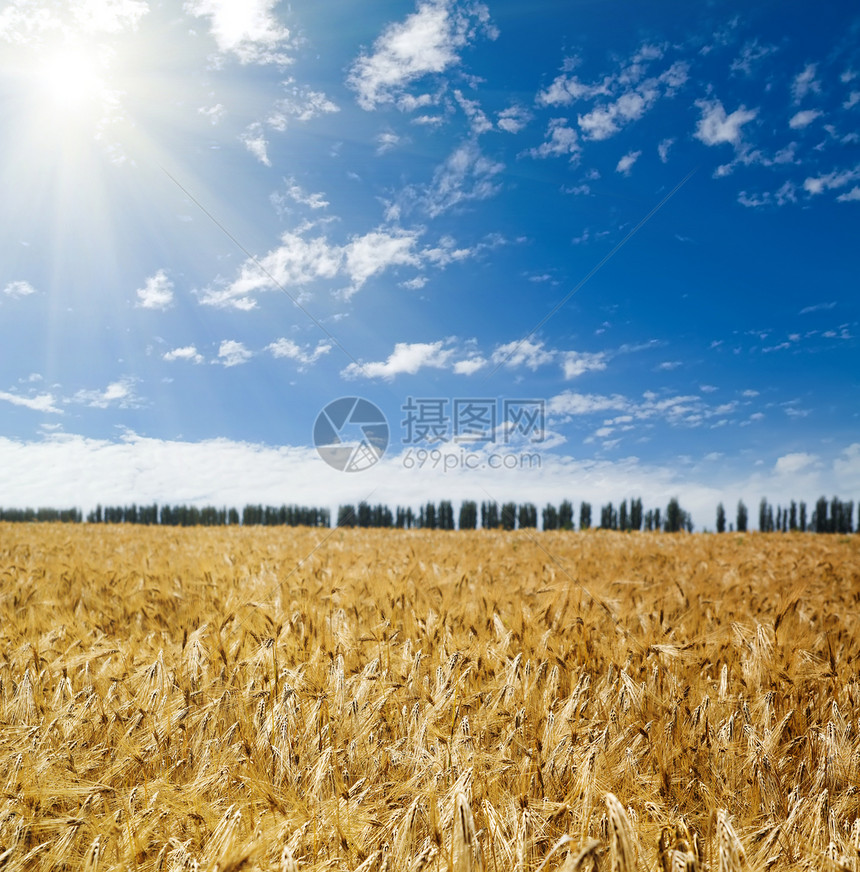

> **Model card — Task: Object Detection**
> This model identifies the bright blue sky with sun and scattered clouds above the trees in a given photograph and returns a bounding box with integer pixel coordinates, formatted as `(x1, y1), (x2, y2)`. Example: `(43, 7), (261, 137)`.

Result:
(0, 0), (860, 527)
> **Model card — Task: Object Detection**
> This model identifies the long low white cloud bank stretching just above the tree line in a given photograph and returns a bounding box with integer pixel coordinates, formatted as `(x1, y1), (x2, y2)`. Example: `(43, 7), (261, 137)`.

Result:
(0, 430), (860, 528)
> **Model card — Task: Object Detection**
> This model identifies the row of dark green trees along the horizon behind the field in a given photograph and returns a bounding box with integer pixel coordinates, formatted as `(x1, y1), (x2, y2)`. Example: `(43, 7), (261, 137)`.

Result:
(0, 496), (860, 533)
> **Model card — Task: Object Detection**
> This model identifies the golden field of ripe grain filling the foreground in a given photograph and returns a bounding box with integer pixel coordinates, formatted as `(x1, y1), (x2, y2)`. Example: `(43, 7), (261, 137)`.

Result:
(0, 524), (860, 872)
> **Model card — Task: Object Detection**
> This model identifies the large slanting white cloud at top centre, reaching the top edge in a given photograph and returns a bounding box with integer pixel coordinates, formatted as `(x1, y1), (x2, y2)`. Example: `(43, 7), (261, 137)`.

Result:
(347, 0), (496, 110)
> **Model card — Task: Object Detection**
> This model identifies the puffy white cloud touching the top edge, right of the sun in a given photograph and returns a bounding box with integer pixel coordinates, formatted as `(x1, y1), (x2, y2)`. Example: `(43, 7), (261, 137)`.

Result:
(185, 0), (292, 66)
